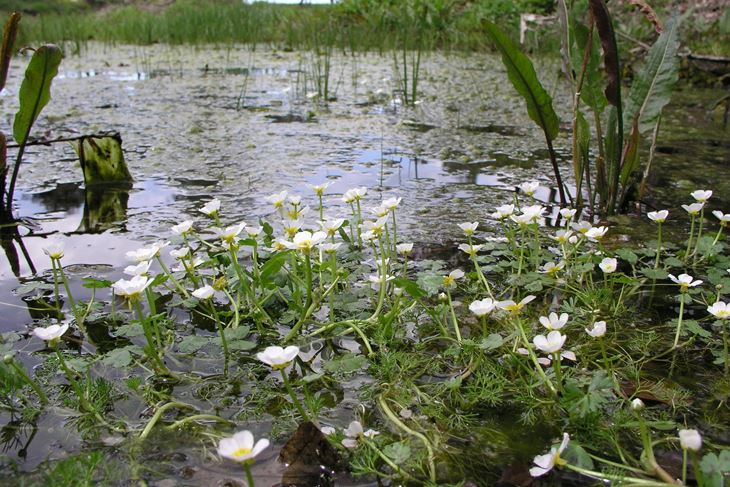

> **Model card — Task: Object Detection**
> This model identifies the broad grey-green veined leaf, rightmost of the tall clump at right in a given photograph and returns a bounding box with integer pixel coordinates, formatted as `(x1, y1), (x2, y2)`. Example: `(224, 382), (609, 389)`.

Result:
(624, 13), (679, 134)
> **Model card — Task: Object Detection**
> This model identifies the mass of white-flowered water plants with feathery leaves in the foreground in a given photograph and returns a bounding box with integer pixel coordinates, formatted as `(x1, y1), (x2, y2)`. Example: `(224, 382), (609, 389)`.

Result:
(0, 183), (730, 486)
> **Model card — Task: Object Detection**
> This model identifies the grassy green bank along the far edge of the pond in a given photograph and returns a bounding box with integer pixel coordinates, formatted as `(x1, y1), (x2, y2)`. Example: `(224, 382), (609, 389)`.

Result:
(0, 0), (730, 56)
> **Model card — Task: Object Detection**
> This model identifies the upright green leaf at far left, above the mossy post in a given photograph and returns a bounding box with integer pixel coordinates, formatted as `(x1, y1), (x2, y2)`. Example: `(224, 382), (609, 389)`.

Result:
(13, 44), (63, 145)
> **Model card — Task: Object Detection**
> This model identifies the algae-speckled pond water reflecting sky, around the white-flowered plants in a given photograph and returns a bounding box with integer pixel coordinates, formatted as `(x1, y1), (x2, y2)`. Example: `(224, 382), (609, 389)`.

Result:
(0, 44), (730, 485)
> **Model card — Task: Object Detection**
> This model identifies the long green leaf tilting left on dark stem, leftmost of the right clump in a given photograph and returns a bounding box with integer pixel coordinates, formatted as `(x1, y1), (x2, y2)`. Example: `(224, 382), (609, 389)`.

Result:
(483, 20), (560, 141)
